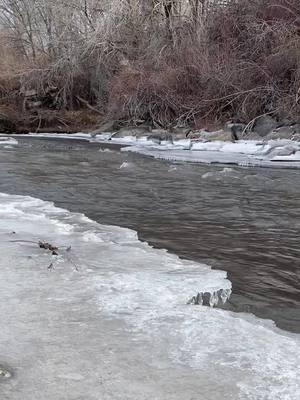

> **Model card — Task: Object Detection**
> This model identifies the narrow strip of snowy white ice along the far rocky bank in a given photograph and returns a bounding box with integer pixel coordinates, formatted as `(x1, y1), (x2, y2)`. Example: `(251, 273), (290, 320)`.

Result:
(17, 133), (300, 168)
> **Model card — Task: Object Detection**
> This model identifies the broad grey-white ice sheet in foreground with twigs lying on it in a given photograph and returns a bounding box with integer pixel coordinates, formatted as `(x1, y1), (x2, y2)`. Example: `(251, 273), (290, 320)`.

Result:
(0, 194), (300, 400)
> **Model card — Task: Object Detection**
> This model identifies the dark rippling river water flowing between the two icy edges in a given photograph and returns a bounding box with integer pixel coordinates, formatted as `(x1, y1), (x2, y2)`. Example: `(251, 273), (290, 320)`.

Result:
(0, 138), (300, 332)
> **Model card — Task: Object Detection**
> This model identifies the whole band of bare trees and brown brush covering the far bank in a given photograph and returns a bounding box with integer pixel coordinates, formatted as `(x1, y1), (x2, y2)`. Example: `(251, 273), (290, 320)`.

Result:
(0, 0), (300, 131)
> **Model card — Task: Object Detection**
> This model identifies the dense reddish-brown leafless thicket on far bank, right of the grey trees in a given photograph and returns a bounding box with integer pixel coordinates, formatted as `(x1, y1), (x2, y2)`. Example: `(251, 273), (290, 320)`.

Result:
(109, 0), (300, 126)
